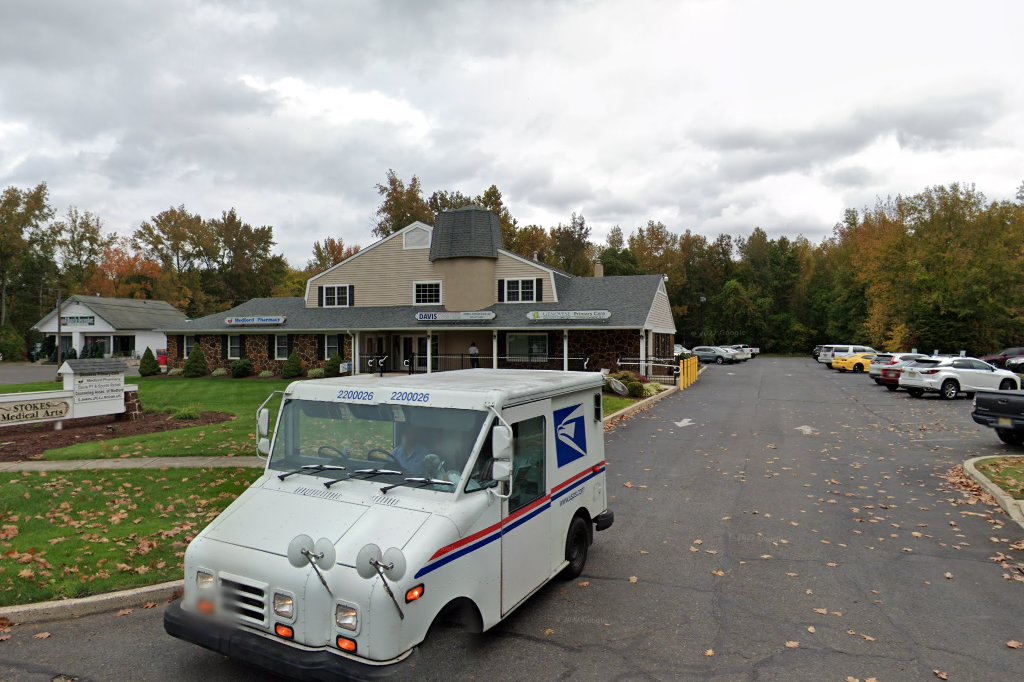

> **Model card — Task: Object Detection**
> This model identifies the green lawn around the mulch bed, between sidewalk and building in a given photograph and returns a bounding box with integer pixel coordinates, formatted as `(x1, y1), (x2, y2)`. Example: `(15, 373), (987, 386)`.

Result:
(0, 377), (291, 460)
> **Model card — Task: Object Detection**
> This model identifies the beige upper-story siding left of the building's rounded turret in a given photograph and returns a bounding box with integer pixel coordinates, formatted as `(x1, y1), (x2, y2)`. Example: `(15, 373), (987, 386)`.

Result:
(306, 237), (444, 308)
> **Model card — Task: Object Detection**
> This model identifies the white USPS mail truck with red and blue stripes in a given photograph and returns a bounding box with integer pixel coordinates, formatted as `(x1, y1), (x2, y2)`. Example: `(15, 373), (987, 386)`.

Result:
(164, 370), (613, 679)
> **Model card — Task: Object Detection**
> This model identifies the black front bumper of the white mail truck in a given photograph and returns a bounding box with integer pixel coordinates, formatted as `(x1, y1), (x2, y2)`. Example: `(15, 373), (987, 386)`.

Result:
(164, 601), (407, 682)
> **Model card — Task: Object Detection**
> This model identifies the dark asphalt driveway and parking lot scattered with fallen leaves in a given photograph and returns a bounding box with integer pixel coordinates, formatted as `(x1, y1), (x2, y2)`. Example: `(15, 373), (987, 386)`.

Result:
(0, 356), (1024, 682)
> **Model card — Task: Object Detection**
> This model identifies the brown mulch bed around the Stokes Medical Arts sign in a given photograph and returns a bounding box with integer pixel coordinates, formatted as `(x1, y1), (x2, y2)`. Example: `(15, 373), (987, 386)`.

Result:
(0, 412), (234, 462)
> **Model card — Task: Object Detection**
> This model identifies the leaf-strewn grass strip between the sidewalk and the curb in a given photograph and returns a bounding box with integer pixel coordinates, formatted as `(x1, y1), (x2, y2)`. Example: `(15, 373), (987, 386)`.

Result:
(0, 469), (262, 606)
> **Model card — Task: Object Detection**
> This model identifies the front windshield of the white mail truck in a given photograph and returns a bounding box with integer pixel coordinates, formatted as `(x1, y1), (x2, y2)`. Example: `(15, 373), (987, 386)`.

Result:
(270, 400), (487, 493)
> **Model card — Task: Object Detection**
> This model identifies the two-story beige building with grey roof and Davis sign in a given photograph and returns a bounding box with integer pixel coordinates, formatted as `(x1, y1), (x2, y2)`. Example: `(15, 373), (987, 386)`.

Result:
(159, 207), (676, 373)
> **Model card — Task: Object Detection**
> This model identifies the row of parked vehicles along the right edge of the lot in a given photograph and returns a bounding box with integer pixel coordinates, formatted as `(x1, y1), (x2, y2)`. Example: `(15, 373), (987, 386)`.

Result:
(813, 344), (1024, 445)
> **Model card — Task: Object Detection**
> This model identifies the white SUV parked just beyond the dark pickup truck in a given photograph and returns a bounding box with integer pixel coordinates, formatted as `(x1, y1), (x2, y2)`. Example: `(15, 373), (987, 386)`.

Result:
(899, 357), (1020, 400)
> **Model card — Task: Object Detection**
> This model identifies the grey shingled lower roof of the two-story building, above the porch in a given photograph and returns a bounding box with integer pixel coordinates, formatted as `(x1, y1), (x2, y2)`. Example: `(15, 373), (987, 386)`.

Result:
(161, 274), (662, 335)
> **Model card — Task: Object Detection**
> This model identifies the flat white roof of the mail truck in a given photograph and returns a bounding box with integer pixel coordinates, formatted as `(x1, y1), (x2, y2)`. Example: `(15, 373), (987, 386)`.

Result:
(286, 369), (604, 407)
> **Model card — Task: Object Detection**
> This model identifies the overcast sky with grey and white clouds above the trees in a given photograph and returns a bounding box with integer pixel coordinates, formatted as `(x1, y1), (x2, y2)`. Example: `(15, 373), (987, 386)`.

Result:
(0, 0), (1024, 265)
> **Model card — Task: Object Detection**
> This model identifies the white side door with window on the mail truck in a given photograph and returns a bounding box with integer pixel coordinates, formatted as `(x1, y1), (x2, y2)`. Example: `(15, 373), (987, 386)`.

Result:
(502, 400), (554, 615)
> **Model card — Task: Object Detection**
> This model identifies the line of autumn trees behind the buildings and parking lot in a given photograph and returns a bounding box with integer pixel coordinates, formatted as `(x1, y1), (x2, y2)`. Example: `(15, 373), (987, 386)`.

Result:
(0, 170), (1024, 358)
